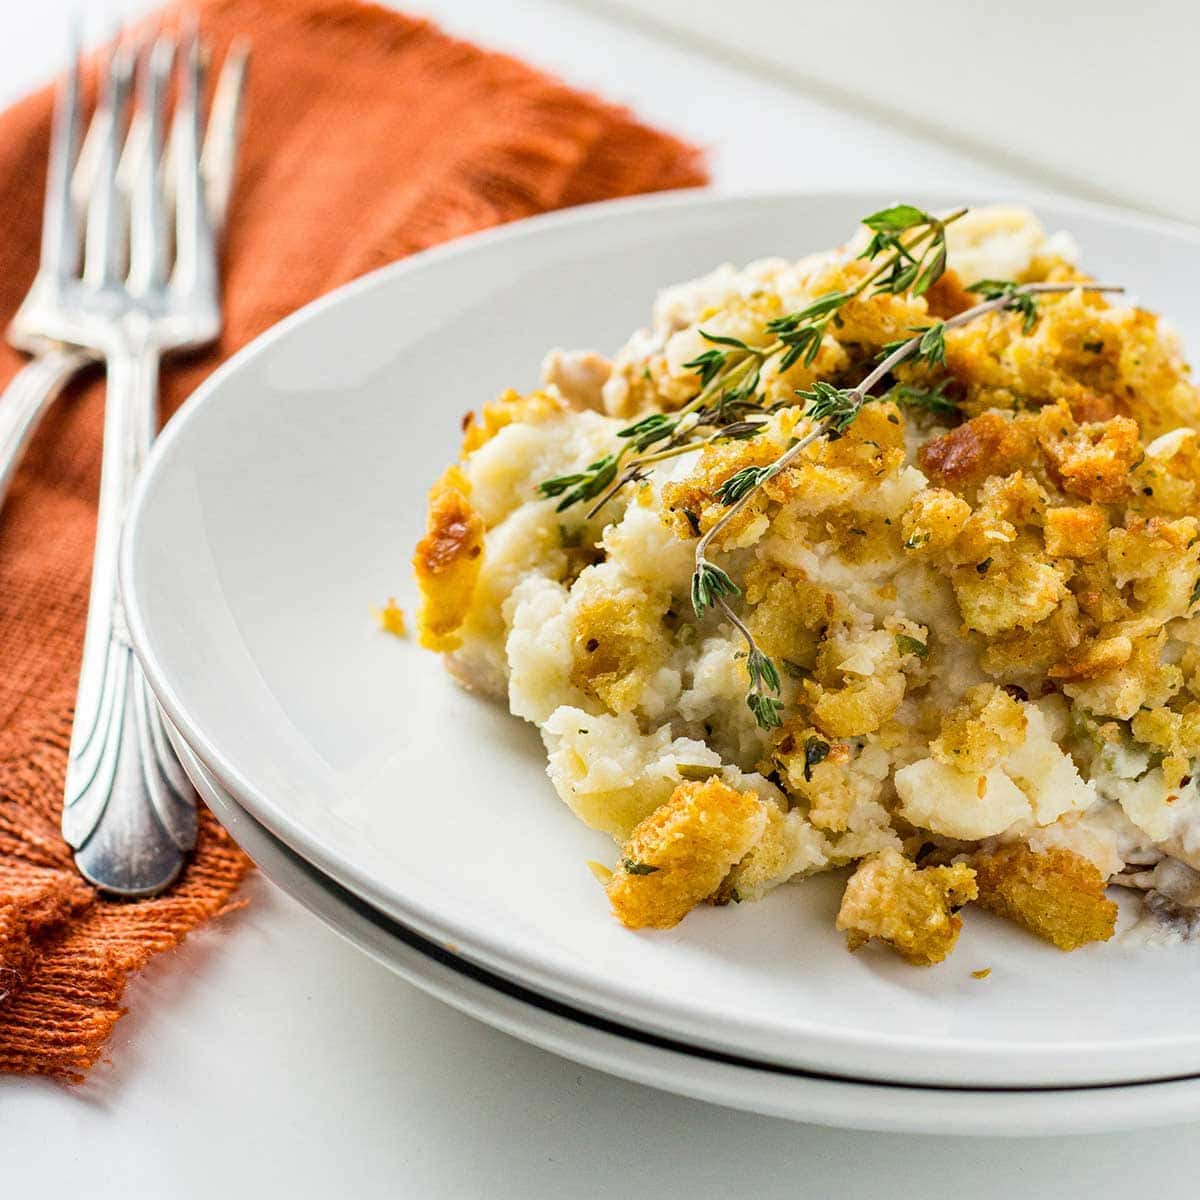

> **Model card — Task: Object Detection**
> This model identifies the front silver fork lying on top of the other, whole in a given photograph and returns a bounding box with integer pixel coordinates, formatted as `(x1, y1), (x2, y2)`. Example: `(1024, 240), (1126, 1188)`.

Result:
(29, 30), (237, 895)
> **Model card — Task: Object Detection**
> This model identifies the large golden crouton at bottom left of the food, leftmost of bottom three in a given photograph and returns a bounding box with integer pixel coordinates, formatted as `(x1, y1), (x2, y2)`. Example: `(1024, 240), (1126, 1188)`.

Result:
(606, 779), (767, 929)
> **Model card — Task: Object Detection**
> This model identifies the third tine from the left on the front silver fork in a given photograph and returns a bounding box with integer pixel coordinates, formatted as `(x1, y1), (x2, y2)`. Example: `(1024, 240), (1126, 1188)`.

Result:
(126, 37), (175, 295)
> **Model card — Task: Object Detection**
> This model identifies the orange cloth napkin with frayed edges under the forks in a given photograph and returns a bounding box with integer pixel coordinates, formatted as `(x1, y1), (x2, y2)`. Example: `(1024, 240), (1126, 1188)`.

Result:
(0, 0), (704, 1080)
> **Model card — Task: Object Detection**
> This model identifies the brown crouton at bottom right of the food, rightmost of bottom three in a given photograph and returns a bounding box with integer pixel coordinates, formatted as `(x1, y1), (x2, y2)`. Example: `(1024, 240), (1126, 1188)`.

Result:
(971, 842), (1117, 950)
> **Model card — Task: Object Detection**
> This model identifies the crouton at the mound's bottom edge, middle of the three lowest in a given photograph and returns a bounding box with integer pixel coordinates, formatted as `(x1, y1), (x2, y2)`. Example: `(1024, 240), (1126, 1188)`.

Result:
(838, 850), (976, 966)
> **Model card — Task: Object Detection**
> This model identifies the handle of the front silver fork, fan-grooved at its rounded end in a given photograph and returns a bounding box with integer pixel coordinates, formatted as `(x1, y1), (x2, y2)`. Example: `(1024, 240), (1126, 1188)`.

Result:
(62, 348), (197, 895)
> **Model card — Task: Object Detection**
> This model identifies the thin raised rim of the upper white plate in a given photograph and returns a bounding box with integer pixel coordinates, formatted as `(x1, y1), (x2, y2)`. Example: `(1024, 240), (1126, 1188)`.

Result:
(120, 188), (1200, 1086)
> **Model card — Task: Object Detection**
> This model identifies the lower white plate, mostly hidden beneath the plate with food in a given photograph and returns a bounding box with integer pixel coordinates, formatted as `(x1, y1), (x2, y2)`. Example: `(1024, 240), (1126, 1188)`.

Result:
(162, 715), (1200, 1138)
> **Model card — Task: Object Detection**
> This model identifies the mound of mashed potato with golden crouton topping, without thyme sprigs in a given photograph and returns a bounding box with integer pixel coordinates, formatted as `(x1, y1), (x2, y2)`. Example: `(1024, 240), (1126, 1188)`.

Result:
(415, 201), (1200, 962)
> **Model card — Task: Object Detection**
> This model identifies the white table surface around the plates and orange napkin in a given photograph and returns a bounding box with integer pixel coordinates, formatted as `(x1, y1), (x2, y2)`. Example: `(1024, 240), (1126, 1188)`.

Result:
(0, 0), (1200, 1200)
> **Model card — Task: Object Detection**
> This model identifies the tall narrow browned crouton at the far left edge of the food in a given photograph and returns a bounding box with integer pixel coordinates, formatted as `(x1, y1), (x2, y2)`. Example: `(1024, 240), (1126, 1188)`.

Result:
(413, 467), (484, 650)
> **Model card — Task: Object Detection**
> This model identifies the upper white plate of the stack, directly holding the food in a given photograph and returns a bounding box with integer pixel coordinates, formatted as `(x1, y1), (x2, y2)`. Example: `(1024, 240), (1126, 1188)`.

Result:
(124, 184), (1200, 1087)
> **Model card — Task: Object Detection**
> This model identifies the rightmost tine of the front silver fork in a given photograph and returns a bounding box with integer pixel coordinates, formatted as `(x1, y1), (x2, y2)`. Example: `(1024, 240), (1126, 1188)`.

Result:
(172, 29), (216, 295)
